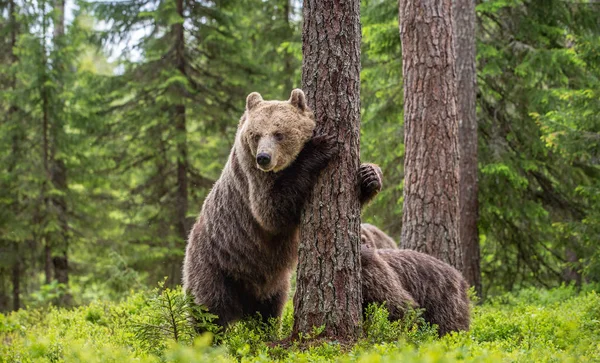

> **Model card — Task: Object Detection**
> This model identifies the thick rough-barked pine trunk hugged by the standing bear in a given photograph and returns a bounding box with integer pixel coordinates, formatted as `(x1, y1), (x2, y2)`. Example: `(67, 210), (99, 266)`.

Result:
(294, 0), (362, 341)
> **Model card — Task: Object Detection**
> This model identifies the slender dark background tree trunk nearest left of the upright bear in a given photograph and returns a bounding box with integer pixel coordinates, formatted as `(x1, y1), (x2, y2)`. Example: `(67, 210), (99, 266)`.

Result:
(171, 0), (189, 284)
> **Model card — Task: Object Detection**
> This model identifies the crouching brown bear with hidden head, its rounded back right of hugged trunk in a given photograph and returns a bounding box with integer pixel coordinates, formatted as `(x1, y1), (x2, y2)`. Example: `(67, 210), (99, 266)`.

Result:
(361, 249), (470, 336)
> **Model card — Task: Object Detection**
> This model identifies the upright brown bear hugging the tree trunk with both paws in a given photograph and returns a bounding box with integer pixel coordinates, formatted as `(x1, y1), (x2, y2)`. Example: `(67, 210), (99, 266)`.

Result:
(183, 89), (381, 326)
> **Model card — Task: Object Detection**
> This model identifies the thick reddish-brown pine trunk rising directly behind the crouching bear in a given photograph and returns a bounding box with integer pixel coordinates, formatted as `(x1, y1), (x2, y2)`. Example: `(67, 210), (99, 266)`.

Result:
(399, 0), (462, 270)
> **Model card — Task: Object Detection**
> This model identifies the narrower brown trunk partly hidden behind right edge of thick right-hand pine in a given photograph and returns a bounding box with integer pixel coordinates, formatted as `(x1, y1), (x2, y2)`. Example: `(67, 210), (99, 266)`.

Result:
(452, 0), (481, 296)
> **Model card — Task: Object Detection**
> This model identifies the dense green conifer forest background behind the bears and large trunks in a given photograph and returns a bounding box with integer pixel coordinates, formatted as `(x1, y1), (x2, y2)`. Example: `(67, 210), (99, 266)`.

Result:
(0, 0), (600, 311)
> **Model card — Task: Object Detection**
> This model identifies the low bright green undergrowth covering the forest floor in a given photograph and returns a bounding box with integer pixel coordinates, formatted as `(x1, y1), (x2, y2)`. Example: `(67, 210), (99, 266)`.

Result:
(0, 286), (600, 362)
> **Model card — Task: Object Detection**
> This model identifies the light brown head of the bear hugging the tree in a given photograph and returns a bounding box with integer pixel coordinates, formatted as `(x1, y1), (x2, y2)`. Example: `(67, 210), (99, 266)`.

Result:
(240, 89), (315, 172)
